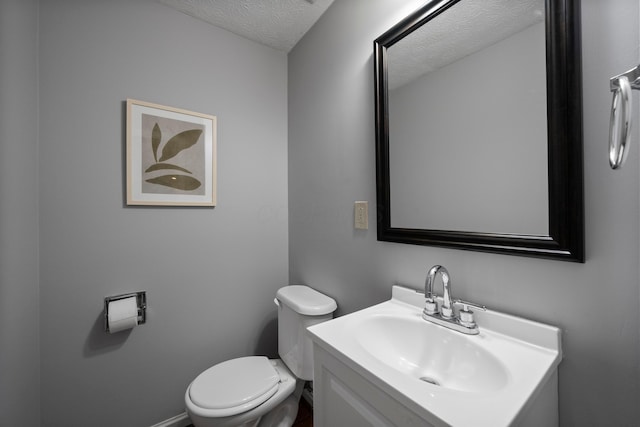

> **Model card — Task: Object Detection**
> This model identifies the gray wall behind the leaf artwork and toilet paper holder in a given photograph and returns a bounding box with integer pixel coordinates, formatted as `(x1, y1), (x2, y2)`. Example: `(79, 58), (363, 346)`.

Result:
(38, 0), (288, 427)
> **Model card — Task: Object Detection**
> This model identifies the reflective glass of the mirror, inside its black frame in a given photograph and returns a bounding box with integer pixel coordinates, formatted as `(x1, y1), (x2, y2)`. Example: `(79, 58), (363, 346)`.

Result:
(388, 0), (549, 235)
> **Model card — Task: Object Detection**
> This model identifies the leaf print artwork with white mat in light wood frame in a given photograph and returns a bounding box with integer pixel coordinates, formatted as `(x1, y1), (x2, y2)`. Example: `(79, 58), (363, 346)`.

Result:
(127, 99), (216, 206)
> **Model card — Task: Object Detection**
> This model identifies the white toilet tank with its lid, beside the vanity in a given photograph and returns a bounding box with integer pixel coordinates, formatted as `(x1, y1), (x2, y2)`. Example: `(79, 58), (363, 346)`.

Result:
(275, 285), (337, 381)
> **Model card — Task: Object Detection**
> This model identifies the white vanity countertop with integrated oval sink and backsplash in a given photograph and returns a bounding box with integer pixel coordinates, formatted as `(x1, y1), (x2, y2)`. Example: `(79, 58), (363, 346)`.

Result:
(308, 286), (562, 427)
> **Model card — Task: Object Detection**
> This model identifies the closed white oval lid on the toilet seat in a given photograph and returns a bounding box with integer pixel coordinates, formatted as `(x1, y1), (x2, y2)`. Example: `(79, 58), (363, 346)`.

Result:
(189, 356), (280, 416)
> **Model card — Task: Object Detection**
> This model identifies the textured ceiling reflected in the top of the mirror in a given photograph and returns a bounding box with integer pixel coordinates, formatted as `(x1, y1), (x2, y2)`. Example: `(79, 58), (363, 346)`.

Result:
(387, 0), (544, 89)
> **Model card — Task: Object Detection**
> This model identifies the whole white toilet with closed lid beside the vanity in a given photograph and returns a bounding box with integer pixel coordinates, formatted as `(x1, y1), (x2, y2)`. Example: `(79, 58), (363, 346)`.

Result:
(184, 285), (337, 427)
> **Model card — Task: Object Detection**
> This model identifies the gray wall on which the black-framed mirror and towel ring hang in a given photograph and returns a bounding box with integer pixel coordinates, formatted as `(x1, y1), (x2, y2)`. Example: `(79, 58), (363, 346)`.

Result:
(289, 0), (640, 427)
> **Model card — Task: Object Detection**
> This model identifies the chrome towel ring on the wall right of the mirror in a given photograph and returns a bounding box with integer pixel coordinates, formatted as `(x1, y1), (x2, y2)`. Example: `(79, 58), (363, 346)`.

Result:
(609, 65), (640, 169)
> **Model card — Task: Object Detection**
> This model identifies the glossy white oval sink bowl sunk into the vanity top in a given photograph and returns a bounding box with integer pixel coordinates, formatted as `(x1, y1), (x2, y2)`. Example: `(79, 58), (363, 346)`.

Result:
(349, 313), (508, 392)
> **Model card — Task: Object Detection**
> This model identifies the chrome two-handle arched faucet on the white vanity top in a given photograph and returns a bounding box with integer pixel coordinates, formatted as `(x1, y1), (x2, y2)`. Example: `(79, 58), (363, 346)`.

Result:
(422, 265), (486, 335)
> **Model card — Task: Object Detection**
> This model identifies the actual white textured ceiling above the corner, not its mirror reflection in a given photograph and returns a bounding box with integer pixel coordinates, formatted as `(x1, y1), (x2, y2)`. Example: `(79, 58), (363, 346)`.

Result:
(158, 0), (333, 52)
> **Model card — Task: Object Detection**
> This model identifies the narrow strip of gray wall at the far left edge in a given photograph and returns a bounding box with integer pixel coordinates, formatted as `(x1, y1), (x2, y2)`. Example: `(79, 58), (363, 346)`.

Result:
(0, 0), (40, 427)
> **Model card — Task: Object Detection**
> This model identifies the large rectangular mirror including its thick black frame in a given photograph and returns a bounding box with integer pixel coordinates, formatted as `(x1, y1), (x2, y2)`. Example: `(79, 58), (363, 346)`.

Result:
(374, 0), (584, 262)
